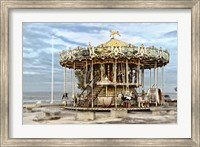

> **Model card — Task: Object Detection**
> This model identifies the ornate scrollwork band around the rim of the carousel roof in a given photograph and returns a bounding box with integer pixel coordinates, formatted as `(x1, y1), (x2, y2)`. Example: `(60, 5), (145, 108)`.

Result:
(59, 44), (169, 62)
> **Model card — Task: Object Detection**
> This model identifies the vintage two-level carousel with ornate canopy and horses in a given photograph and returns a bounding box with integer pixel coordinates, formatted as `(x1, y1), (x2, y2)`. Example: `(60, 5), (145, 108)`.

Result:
(60, 30), (170, 108)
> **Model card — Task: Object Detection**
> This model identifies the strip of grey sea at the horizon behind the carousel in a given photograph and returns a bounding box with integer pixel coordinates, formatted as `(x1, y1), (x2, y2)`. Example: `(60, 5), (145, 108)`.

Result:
(23, 92), (177, 104)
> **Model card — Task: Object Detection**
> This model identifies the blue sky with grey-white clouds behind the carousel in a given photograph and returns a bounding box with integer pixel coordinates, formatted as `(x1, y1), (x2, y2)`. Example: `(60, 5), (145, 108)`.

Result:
(23, 23), (177, 92)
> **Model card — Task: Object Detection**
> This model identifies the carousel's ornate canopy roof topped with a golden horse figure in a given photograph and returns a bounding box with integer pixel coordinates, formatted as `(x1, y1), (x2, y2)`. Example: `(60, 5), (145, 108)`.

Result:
(60, 31), (170, 69)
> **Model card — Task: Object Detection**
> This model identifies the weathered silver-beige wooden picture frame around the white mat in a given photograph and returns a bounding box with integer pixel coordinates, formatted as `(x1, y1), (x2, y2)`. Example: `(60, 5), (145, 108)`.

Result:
(0, 0), (200, 146)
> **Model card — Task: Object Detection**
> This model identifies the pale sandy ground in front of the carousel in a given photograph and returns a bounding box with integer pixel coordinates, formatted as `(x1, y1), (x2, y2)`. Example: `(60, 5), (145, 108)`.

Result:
(23, 106), (177, 124)
